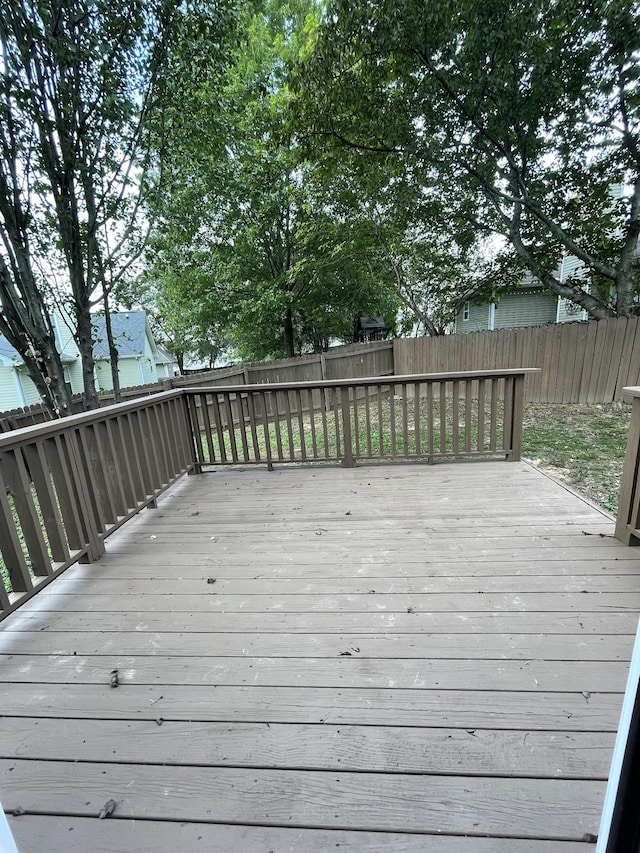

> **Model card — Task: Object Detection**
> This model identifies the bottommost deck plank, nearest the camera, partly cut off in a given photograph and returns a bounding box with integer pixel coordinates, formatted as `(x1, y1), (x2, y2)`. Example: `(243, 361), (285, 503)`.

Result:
(9, 815), (594, 853)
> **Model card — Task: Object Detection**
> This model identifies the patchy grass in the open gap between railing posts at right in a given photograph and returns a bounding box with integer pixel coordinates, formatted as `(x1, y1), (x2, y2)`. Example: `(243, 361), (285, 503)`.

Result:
(522, 403), (630, 513)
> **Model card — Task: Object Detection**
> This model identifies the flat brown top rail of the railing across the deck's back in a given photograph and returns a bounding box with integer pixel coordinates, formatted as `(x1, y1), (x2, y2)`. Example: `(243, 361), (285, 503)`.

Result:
(184, 367), (540, 394)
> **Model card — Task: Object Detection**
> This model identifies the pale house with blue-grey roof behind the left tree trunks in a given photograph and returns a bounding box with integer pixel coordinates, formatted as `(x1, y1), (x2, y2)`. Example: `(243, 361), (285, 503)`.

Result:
(0, 311), (179, 412)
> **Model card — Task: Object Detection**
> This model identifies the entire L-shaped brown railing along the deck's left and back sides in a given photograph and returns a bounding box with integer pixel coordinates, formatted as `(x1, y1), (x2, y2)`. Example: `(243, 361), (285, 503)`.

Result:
(0, 369), (531, 618)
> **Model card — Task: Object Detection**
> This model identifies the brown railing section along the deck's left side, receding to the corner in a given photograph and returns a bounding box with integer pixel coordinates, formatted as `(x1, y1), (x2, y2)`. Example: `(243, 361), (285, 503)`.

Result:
(0, 391), (193, 617)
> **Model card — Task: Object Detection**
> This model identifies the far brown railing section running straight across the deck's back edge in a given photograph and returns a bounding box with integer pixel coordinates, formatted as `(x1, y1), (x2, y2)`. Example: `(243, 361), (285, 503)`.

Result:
(188, 370), (534, 469)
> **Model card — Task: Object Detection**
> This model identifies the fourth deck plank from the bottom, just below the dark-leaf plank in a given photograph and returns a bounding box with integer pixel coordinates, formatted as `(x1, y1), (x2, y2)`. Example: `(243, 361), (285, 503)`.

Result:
(0, 684), (622, 728)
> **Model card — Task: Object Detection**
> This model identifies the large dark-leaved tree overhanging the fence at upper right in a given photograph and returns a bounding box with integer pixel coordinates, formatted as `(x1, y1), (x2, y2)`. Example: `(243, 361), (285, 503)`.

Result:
(296, 0), (640, 318)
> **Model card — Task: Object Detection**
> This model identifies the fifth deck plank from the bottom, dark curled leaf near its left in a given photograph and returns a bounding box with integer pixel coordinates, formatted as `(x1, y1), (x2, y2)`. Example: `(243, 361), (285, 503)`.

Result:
(0, 654), (629, 693)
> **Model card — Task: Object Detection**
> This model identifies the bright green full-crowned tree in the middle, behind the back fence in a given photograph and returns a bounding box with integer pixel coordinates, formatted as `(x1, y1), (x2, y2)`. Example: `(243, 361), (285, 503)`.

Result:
(148, 0), (395, 358)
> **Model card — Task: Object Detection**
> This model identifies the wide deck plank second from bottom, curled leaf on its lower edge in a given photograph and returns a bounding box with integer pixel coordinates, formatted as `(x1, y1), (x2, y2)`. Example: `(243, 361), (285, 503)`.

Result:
(0, 760), (604, 840)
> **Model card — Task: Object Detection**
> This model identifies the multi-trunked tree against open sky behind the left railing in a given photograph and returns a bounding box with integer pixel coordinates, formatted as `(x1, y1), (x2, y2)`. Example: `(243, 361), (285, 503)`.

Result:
(0, 0), (177, 409)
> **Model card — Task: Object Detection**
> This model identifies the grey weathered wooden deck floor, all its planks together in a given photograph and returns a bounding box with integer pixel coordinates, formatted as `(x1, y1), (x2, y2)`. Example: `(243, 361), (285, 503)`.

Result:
(0, 462), (640, 853)
